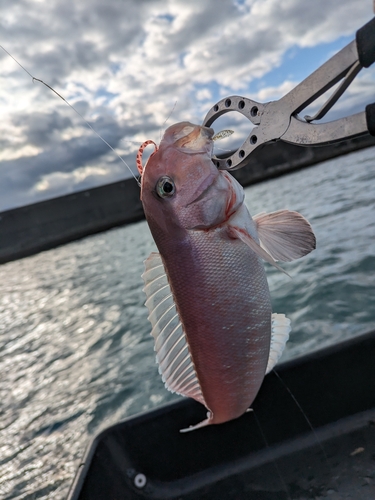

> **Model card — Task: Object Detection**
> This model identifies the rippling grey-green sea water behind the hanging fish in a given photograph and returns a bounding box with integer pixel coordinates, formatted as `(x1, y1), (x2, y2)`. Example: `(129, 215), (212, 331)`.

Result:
(0, 148), (375, 500)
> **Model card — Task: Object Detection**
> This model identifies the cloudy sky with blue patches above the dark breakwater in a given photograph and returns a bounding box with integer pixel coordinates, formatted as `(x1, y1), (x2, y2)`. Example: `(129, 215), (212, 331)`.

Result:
(0, 0), (375, 211)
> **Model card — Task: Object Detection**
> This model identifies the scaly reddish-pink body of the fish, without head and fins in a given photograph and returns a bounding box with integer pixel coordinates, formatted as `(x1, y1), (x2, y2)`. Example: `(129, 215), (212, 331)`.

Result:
(162, 225), (271, 423)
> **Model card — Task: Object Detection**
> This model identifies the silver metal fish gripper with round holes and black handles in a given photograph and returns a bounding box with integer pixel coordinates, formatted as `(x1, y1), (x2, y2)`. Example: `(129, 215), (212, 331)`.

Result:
(203, 17), (375, 170)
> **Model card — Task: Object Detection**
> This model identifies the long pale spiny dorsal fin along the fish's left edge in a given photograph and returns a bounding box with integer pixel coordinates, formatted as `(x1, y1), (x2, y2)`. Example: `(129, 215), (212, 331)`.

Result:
(142, 252), (206, 406)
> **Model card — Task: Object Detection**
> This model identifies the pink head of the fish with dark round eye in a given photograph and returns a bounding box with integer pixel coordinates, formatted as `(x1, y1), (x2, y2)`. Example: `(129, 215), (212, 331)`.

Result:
(141, 122), (243, 231)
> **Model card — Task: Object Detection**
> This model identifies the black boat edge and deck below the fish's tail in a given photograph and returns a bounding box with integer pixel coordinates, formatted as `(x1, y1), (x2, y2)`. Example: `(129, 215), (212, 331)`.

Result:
(69, 332), (375, 500)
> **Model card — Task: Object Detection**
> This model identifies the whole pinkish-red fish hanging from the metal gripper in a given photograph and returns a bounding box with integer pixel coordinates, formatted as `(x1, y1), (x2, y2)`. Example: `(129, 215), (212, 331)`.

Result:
(137, 122), (316, 432)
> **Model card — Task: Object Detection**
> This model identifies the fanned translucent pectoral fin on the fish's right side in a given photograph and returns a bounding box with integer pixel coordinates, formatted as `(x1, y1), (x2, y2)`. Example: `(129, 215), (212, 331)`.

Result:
(253, 210), (316, 262)
